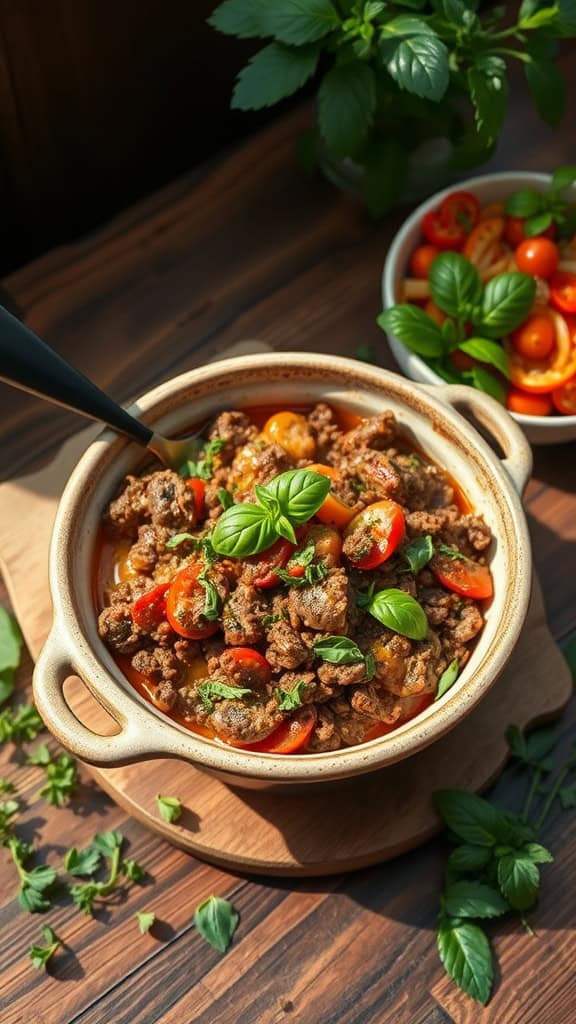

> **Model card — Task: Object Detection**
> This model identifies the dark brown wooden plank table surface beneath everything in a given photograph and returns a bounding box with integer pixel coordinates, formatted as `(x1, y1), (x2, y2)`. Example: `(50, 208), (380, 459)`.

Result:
(0, 66), (576, 1024)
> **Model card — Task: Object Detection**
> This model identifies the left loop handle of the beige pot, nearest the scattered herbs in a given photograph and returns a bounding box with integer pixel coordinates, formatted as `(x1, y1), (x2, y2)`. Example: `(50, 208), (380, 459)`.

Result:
(33, 630), (168, 768)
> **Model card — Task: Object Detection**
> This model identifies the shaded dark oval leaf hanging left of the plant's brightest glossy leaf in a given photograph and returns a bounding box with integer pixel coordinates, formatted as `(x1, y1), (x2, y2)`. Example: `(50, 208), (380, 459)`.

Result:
(318, 60), (376, 157)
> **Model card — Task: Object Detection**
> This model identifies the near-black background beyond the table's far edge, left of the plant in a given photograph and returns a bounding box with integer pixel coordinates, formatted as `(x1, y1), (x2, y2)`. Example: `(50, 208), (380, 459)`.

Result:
(0, 0), (271, 274)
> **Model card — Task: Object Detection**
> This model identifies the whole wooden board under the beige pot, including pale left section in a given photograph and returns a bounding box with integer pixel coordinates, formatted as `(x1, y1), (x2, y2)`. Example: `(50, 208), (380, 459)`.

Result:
(0, 342), (572, 876)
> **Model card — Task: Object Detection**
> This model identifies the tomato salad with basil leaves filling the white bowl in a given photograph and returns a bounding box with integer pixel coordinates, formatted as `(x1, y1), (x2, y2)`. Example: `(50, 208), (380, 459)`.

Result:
(378, 167), (576, 416)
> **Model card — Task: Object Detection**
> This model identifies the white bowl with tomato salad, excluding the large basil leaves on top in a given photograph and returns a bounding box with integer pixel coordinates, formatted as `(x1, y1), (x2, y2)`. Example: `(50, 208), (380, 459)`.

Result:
(382, 169), (576, 444)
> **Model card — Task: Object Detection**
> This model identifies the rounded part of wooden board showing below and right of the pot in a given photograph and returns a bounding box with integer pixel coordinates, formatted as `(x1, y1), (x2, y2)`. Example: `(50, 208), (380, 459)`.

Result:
(60, 583), (572, 876)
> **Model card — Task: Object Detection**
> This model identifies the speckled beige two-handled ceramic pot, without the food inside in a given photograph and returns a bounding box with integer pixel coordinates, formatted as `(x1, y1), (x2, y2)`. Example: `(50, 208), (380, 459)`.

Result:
(34, 353), (531, 786)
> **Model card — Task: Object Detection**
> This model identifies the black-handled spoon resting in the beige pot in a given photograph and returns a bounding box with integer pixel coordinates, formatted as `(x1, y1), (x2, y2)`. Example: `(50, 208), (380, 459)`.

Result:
(0, 306), (204, 470)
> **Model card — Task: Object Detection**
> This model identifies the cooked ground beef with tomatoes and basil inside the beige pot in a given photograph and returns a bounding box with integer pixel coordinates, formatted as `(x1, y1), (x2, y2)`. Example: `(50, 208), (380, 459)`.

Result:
(97, 403), (492, 754)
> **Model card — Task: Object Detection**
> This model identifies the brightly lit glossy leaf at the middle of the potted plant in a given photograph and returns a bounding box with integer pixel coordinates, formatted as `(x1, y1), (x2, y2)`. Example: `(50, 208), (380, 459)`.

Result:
(380, 34), (450, 103)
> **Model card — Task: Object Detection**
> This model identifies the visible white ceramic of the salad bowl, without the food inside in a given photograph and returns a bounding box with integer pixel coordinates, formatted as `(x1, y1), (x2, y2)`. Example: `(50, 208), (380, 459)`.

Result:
(382, 171), (576, 444)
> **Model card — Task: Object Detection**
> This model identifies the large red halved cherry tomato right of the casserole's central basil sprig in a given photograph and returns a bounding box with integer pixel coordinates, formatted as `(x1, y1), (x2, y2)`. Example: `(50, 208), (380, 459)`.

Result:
(344, 499), (406, 569)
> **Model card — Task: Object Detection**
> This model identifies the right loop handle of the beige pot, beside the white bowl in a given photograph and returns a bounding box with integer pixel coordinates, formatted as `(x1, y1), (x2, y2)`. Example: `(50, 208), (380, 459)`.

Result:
(424, 384), (532, 497)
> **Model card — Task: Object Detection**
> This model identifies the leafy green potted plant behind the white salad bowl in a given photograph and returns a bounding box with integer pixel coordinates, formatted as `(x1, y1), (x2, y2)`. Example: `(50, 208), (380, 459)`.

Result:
(209, 0), (576, 215)
